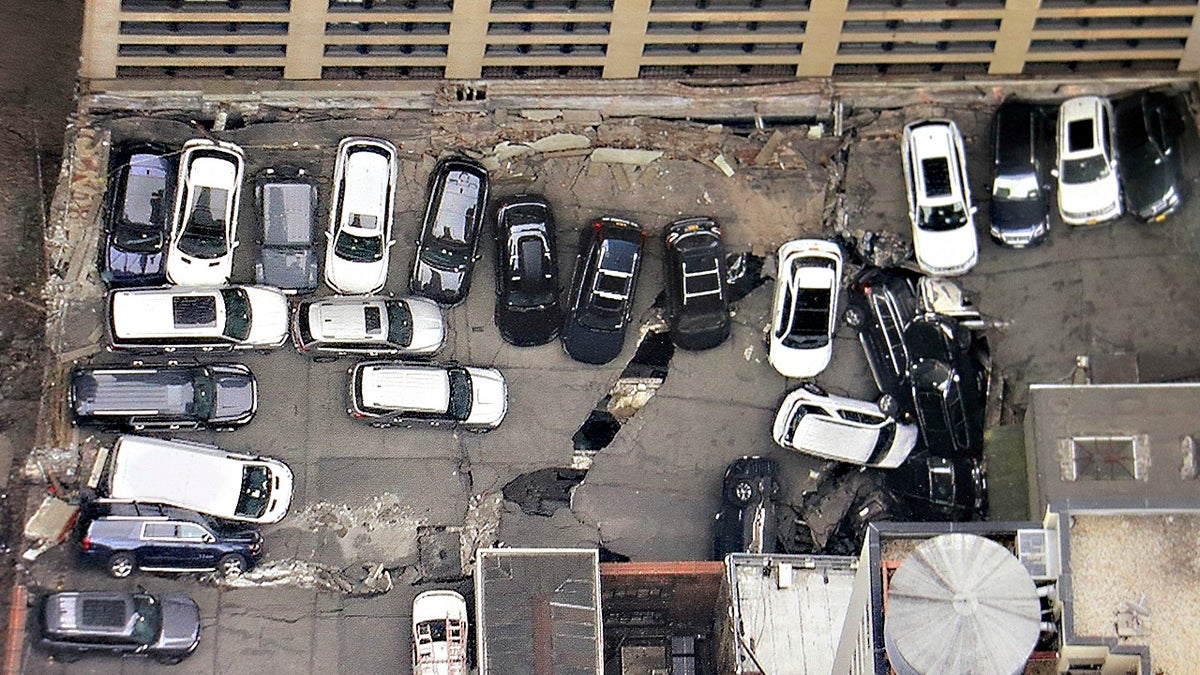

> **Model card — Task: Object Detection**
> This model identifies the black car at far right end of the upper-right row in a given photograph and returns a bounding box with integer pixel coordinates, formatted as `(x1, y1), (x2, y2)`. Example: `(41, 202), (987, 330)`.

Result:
(1114, 91), (1188, 221)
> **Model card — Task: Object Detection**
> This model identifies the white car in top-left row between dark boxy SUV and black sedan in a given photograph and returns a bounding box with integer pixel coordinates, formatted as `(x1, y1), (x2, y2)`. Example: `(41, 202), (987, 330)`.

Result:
(325, 136), (397, 295)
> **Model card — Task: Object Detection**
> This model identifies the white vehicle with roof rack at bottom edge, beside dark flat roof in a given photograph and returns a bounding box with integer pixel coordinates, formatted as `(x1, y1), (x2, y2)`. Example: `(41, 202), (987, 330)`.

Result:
(413, 591), (468, 675)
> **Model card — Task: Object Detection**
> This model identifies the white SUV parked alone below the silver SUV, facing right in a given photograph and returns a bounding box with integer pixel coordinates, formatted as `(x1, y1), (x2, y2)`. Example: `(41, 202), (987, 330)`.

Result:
(346, 360), (509, 431)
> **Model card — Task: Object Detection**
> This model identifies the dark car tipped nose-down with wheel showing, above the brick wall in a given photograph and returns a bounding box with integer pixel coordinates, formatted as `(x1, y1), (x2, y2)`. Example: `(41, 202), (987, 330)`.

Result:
(713, 456), (779, 560)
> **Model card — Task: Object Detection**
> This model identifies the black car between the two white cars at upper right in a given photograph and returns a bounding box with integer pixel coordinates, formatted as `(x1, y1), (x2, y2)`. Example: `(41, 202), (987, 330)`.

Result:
(988, 101), (1050, 249)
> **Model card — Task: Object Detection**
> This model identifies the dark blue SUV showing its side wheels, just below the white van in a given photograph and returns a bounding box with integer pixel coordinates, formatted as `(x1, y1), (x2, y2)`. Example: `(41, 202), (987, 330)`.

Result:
(79, 502), (263, 579)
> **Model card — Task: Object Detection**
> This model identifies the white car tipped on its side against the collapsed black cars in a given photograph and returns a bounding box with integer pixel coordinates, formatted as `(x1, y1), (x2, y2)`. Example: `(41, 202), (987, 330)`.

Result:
(772, 384), (917, 468)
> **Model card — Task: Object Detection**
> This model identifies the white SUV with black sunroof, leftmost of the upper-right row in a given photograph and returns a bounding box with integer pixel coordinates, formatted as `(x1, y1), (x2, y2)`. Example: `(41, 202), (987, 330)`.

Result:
(900, 119), (979, 276)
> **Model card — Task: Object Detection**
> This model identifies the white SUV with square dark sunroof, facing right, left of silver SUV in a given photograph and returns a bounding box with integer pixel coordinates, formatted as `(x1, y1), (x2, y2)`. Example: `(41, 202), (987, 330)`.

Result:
(107, 286), (288, 352)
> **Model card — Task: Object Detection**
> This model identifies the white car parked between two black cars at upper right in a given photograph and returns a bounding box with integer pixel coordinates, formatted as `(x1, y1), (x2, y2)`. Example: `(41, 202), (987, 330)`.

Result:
(1054, 96), (1123, 225)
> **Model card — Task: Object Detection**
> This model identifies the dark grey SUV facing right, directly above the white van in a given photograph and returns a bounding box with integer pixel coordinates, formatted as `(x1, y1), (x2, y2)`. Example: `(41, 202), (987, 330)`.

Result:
(67, 363), (258, 431)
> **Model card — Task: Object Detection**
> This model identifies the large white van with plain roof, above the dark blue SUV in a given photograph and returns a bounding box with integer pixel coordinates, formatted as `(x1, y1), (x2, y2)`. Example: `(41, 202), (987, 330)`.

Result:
(101, 436), (292, 524)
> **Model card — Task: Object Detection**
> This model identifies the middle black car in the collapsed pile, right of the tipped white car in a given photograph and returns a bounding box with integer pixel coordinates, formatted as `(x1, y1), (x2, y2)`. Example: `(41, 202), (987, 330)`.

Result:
(904, 315), (990, 458)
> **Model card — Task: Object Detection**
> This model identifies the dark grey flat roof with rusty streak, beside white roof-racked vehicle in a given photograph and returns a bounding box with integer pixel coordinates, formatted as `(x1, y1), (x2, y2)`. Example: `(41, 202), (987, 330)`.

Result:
(475, 549), (604, 675)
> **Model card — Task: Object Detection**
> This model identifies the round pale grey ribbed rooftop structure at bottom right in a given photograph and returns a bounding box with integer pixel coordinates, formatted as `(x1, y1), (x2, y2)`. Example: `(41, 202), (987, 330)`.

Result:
(883, 534), (1040, 675)
